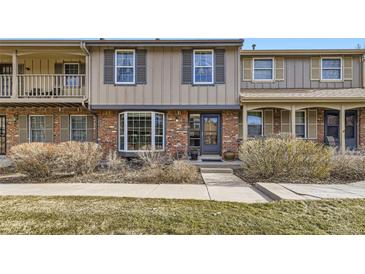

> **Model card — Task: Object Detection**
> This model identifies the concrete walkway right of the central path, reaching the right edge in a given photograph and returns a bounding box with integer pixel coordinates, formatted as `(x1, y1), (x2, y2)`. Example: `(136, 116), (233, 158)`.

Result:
(256, 182), (365, 200)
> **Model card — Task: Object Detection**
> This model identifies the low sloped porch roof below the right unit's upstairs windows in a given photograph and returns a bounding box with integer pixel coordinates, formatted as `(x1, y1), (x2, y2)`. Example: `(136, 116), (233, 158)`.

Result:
(240, 88), (365, 104)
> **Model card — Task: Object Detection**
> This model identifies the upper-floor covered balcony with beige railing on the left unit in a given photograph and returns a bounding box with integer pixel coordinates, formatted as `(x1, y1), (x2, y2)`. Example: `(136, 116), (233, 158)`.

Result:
(0, 43), (88, 104)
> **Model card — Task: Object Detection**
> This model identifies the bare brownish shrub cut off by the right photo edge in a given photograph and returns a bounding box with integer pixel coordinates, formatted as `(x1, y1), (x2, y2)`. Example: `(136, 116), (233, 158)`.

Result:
(331, 151), (365, 180)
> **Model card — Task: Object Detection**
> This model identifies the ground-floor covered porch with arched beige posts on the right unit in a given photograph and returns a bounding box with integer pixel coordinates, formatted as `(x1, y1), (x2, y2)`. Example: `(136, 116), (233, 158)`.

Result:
(240, 88), (365, 153)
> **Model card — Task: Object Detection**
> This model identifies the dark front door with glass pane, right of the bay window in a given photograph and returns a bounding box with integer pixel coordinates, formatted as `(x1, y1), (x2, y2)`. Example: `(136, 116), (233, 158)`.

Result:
(201, 114), (221, 154)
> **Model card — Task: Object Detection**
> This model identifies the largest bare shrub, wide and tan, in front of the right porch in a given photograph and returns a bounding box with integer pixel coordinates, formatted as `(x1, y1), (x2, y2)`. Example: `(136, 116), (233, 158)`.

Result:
(239, 137), (333, 181)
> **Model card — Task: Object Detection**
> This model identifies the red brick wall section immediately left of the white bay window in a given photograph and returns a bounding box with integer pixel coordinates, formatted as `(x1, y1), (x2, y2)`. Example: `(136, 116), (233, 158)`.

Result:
(97, 110), (118, 153)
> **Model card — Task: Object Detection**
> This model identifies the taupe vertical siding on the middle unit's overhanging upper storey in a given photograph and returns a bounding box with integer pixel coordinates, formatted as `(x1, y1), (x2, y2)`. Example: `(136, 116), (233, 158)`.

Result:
(90, 47), (239, 106)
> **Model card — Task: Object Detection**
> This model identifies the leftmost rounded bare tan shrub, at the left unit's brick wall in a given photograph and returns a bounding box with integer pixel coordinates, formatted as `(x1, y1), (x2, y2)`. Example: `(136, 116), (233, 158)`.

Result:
(10, 143), (58, 178)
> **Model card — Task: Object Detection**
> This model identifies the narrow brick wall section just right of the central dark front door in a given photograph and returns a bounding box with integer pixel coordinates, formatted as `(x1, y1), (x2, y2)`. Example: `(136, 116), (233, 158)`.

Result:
(222, 111), (239, 157)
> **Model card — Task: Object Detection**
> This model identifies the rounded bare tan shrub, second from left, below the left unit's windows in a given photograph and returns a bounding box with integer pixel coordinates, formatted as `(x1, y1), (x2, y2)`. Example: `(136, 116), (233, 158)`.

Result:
(57, 142), (103, 174)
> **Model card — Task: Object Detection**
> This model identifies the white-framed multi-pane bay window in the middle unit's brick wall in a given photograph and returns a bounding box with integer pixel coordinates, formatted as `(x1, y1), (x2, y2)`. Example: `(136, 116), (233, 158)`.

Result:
(119, 111), (165, 151)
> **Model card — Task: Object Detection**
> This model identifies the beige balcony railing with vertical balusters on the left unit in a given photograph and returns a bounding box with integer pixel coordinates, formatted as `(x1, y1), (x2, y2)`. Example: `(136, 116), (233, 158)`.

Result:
(0, 74), (85, 98)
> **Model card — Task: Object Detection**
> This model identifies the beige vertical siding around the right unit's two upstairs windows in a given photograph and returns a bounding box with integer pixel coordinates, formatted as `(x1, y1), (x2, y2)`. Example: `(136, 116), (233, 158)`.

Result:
(240, 56), (361, 89)
